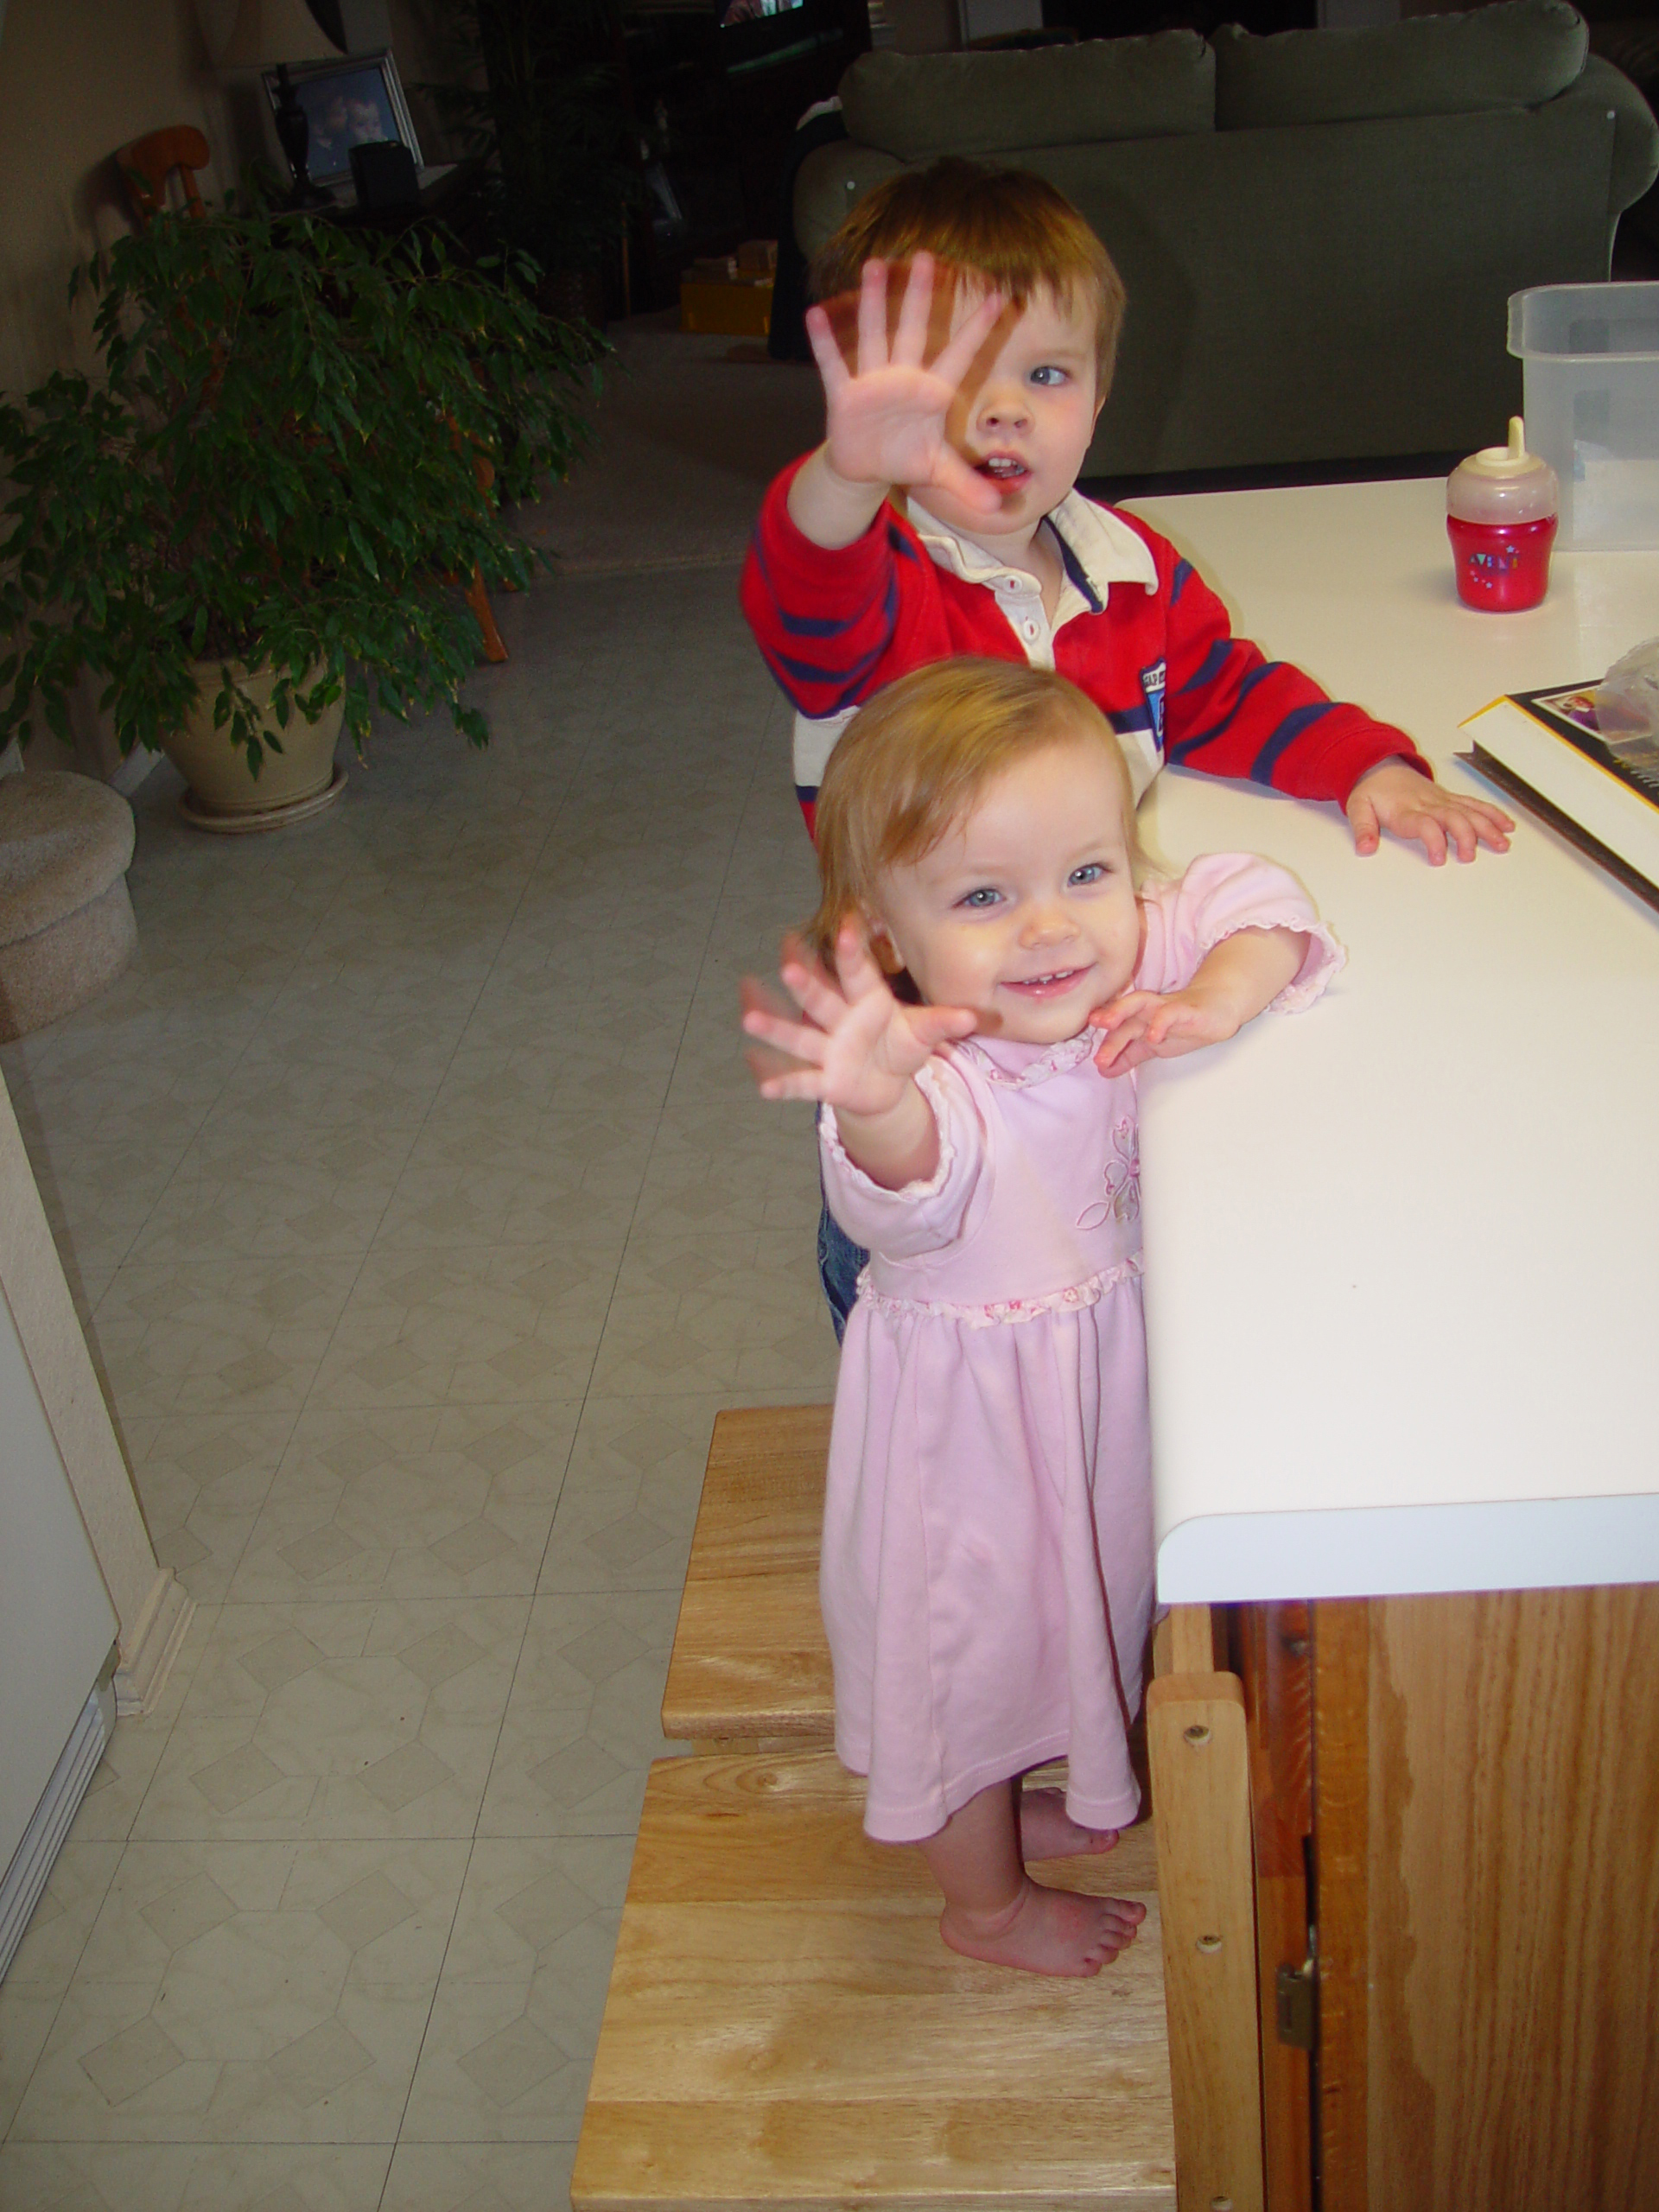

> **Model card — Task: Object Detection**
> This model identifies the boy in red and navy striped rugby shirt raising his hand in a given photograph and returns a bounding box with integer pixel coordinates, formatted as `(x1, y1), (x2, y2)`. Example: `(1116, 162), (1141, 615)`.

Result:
(743, 159), (1513, 865)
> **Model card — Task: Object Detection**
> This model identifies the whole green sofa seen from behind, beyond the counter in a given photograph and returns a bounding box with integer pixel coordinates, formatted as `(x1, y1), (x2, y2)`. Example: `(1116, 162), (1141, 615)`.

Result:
(791, 0), (1659, 478)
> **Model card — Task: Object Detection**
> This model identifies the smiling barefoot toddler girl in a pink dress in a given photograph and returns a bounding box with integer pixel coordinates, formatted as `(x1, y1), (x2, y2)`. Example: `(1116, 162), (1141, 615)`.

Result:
(743, 659), (1343, 1975)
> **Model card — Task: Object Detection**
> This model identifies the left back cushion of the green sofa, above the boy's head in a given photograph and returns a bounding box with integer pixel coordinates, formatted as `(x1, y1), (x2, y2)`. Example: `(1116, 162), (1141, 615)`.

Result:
(841, 31), (1214, 162)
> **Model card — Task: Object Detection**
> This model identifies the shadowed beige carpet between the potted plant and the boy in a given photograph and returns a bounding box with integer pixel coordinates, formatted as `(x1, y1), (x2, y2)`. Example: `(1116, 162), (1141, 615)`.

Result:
(520, 309), (823, 575)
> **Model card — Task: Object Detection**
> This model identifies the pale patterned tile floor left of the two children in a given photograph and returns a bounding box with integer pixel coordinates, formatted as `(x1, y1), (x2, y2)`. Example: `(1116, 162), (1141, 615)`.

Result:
(0, 569), (834, 2212)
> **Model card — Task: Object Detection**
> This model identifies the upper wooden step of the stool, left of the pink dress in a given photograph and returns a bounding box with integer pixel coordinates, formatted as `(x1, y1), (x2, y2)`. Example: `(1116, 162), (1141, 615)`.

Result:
(661, 1405), (836, 1752)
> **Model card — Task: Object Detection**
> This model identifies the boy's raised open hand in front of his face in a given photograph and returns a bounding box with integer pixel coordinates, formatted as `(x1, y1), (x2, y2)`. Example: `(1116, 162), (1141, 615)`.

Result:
(807, 254), (1007, 515)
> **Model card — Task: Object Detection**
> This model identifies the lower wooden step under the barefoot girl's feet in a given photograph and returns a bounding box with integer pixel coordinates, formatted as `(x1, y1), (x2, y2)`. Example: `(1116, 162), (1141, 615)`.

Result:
(570, 1752), (1174, 2212)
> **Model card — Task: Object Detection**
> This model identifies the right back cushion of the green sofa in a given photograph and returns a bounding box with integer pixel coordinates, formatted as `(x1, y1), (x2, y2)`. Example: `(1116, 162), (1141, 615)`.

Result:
(1212, 0), (1588, 130)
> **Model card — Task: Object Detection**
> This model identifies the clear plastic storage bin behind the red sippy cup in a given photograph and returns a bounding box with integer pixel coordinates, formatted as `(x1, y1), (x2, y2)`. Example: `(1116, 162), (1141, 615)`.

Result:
(1509, 283), (1659, 546)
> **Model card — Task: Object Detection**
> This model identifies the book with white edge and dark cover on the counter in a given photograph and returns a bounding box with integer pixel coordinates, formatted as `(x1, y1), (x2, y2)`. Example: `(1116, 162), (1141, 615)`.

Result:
(1460, 683), (1659, 907)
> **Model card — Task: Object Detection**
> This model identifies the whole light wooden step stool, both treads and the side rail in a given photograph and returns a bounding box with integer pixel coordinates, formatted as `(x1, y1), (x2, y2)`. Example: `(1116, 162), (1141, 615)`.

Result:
(619, 1407), (1263, 2212)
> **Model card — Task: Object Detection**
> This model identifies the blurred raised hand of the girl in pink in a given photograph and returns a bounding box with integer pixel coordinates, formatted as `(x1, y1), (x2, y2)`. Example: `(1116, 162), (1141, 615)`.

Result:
(741, 923), (976, 1119)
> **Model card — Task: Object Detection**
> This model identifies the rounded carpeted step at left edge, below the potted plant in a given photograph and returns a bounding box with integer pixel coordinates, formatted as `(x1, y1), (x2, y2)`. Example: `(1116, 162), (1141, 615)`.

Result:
(0, 767), (137, 1042)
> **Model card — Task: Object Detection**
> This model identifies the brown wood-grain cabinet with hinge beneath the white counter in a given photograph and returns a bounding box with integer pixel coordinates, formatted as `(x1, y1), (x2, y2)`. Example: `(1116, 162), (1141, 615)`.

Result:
(1221, 1586), (1659, 2212)
